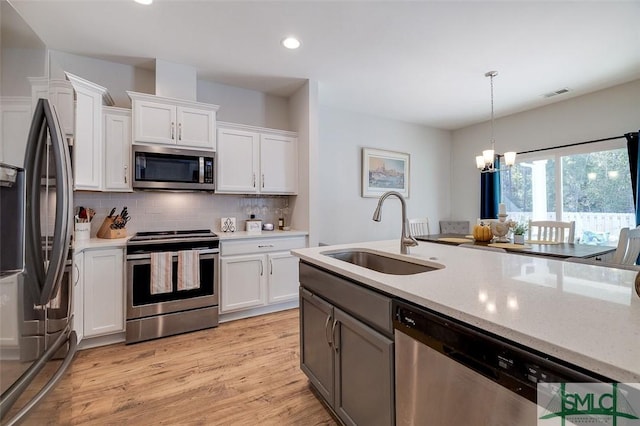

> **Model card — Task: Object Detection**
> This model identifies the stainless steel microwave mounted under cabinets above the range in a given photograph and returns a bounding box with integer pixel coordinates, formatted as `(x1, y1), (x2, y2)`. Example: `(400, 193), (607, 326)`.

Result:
(132, 145), (215, 191)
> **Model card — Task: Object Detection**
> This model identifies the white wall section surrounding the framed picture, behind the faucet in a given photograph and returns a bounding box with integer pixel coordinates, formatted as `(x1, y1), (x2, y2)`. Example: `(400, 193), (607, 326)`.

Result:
(317, 106), (451, 244)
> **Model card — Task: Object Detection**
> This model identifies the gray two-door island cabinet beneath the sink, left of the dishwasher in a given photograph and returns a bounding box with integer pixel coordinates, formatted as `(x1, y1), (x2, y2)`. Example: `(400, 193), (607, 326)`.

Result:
(300, 264), (395, 425)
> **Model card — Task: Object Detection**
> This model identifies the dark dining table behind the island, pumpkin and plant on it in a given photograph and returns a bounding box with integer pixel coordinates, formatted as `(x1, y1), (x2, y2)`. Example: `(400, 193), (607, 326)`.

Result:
(414, 234), (616, 260)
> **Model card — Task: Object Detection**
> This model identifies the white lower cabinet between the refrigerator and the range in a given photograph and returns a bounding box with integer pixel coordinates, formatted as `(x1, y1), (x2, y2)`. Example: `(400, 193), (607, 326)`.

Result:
(74, 248), (125, 338)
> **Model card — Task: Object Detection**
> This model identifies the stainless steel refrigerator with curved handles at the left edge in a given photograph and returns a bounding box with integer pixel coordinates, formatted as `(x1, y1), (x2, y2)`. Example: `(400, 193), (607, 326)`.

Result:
(0, 99), (76, 425)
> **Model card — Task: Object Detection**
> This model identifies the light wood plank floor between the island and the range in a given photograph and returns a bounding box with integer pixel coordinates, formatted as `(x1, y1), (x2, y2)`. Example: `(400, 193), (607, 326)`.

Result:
(12, 309), (336, 425)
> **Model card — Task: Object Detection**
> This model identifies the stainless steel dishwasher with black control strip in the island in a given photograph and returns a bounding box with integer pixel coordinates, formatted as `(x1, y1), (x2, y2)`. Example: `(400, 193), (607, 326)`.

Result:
(393, 301), (611, 426)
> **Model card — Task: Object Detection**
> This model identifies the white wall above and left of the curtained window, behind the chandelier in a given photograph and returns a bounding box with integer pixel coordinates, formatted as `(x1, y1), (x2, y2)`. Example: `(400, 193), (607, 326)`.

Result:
(451, 80), (640, 226)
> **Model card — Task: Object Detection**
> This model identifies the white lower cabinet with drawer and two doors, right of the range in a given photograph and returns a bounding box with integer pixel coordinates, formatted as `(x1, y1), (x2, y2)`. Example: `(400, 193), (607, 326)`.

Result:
(220, 236), (306, 313)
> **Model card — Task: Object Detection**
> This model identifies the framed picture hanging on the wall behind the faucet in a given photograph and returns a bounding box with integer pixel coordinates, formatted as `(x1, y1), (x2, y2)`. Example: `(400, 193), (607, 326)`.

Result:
(362, 148), (409, 198)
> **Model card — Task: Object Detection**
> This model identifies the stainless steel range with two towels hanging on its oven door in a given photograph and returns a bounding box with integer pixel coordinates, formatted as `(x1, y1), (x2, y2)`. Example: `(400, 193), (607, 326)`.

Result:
(126, 229), (220, 343)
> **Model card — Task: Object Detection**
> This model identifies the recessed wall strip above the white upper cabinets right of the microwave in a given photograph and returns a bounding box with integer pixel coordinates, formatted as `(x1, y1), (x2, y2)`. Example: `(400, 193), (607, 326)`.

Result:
(198, 80), (295, 130)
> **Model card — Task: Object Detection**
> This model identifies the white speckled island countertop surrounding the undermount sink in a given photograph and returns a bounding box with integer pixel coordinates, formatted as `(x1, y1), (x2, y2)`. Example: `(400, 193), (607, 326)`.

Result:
(293, 240), (640, 383)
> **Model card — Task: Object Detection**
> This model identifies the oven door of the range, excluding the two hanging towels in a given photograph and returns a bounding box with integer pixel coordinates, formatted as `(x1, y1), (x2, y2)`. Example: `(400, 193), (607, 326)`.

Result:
(127, 249), (219, 320)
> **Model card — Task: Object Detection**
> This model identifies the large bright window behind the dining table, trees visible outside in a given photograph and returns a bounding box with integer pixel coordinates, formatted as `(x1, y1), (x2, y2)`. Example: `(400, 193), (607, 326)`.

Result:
(500, 141), (635, 246)
